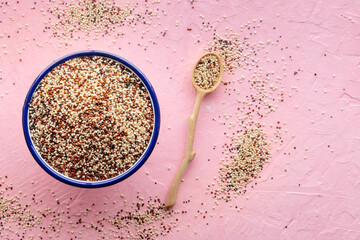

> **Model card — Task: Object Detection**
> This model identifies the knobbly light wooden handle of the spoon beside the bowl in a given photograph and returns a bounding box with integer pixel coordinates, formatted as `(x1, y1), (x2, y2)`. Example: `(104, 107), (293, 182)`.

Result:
(165, 91), (206, 208)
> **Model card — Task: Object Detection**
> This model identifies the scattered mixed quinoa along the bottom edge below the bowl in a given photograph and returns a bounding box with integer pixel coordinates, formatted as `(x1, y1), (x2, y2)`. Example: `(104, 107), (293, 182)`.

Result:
(0, 175), (181, 240)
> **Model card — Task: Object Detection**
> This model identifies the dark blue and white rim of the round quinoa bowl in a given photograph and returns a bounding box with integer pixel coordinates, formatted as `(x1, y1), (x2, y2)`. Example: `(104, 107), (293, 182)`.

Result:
(22, 50), (160, 188)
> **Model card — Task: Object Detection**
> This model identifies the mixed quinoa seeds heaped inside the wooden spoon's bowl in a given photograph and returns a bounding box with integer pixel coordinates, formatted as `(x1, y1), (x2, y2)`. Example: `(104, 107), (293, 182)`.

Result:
(194, 54), (220, 90)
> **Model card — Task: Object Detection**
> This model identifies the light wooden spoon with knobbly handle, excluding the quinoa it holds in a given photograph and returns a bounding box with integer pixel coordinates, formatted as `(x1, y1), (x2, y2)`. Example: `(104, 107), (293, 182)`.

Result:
(165, 52), (223, 208)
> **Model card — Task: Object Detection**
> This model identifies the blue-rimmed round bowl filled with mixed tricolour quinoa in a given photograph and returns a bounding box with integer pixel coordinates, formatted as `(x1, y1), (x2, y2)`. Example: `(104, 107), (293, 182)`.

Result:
(23, 51), (160, 188)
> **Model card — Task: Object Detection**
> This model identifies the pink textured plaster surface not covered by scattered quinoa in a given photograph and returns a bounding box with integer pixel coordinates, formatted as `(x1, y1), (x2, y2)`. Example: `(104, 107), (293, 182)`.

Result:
(0, 0), (360, 240)
